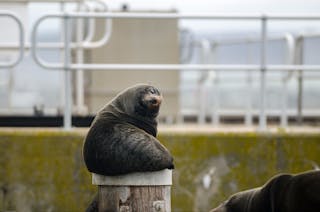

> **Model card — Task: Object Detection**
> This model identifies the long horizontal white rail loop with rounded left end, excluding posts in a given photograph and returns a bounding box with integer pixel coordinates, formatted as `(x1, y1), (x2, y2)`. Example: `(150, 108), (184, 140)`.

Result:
(32, 13), (320, 71)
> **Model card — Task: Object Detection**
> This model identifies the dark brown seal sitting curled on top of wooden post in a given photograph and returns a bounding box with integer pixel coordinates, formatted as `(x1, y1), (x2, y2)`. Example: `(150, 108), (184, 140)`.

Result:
(83, 85), (174, 211)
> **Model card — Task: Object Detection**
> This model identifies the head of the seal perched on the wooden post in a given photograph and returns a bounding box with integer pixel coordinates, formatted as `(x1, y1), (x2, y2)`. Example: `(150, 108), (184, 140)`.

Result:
(115, 84), (163, 119)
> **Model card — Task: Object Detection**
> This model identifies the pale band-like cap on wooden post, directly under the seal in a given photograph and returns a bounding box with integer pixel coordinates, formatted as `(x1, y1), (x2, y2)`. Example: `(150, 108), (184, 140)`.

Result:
(92, 169), (172, 186)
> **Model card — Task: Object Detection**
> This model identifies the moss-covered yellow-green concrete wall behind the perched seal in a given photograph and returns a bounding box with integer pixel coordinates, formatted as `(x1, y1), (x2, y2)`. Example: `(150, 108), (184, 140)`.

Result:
(0, 130), (320, 212)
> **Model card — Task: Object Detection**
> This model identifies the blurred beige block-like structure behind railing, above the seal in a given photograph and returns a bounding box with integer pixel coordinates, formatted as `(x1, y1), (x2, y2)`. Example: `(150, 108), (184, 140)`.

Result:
(86, 14), (179, 121)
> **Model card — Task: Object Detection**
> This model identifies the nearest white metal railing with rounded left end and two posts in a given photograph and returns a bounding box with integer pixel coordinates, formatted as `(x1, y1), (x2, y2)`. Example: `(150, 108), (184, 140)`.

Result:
(32, 13), (320, 131)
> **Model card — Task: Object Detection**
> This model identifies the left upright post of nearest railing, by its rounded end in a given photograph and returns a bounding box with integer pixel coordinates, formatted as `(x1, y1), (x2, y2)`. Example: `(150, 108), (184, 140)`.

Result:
(63, 15), (72, 130)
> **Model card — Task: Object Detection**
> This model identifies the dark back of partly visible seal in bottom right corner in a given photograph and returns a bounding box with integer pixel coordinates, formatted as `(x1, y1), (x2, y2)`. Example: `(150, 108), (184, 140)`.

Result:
(210, 171), (320, 212)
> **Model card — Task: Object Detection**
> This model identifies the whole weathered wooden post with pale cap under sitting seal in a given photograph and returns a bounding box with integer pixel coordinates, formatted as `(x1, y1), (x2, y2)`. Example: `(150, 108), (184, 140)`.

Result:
(92, 169), (172, 212)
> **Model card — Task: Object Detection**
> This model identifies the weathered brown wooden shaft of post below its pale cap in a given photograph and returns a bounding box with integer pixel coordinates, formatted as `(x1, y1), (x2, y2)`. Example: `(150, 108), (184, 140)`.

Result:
(98, 185), (171, 212)
